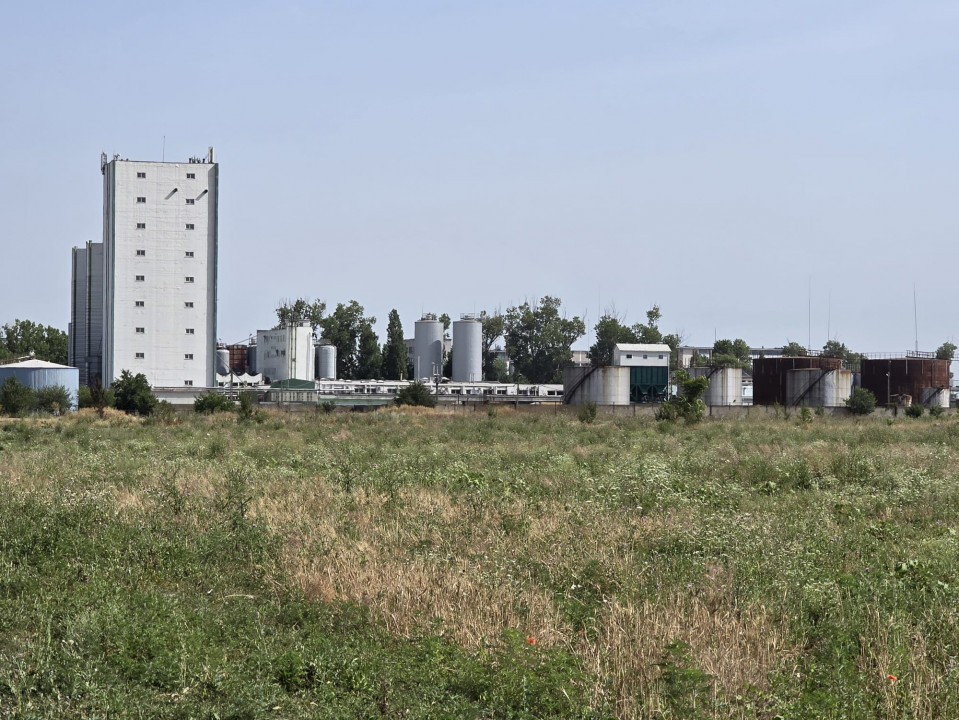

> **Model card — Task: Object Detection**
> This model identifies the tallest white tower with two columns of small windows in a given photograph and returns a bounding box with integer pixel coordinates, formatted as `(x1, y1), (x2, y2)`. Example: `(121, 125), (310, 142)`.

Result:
(100, 148), (219, 387)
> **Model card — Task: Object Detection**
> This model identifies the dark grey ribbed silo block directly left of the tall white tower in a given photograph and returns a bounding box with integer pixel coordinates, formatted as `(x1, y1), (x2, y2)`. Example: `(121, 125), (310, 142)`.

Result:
(67, 242), (103, 385)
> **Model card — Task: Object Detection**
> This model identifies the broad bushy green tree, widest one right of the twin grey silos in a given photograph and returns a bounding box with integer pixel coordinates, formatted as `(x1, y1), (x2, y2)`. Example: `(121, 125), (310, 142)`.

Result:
(504, 295), (586, 383)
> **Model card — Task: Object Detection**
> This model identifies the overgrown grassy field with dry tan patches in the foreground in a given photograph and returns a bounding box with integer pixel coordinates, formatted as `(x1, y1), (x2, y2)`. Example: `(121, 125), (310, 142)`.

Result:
(0, 409), (959, 719)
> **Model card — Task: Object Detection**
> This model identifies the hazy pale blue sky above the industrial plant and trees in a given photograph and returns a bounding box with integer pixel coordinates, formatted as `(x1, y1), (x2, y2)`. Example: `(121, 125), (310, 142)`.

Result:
(0, 0), (959, 352)
